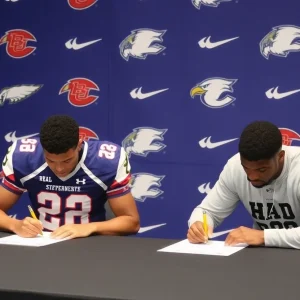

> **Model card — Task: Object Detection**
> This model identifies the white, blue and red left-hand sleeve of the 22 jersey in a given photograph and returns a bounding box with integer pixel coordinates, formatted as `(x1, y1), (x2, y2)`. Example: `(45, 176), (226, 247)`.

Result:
(1, 141), (26, 195)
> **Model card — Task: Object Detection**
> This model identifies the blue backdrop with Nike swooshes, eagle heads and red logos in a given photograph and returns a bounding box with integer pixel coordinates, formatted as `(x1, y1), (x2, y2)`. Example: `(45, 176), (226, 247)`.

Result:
(0, 0), (300, 239)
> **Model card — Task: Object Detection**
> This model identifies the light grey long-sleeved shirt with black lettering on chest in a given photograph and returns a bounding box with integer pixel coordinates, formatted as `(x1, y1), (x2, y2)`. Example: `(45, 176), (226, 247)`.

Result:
(189, 146), (300, 248)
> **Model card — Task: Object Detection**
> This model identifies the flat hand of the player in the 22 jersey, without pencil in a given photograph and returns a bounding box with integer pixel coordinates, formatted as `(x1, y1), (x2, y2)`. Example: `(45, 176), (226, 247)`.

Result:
(51, 223), (93, 239)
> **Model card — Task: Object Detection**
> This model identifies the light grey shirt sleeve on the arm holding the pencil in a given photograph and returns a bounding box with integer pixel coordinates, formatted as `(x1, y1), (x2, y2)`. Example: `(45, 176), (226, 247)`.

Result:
(188, 160), (239, 228)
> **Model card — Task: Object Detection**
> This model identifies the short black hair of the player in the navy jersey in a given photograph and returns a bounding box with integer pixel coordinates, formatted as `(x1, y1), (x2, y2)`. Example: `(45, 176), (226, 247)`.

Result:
(40, 115), (79, 154)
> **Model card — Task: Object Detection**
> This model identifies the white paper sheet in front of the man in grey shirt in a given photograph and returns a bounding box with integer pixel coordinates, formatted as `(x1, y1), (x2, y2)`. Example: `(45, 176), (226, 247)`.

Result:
(158, 239), (247, 256)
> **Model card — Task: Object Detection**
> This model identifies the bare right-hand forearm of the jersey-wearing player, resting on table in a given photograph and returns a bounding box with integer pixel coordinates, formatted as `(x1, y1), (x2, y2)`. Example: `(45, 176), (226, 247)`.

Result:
(90, 216), (140, 235)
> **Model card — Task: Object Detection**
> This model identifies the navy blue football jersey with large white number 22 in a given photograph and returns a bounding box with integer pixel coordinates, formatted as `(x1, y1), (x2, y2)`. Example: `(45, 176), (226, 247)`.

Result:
(1, 138), (130, 231)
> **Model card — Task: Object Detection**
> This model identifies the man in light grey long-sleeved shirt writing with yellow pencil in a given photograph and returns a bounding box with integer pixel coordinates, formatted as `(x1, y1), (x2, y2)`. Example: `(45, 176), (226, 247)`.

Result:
(187, 121), (300, 249)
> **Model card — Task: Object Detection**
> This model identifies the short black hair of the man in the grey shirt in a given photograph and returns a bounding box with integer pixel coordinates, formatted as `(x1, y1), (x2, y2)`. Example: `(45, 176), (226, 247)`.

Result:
(239, 121), (282, 161)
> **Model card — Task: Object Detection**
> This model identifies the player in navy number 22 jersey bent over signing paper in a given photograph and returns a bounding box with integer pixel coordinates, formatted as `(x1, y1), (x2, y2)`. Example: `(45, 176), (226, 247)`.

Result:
(0, 115), (139, 238)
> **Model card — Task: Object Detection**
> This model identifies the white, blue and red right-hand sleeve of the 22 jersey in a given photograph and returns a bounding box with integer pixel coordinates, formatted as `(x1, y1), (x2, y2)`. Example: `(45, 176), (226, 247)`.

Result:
(106, 147), (131, 199)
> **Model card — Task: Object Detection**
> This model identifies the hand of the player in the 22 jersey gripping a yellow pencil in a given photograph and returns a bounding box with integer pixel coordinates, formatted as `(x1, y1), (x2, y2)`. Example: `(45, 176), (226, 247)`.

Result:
(14, 217), (43, 237)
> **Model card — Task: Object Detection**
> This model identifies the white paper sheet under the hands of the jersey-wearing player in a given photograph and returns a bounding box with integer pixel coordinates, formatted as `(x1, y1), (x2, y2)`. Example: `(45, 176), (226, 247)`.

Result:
(0, 231), (66, 247)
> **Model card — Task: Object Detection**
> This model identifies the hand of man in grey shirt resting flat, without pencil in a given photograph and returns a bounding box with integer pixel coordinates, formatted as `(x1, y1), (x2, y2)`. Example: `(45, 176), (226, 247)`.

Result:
(225, 226), (264, 246)
